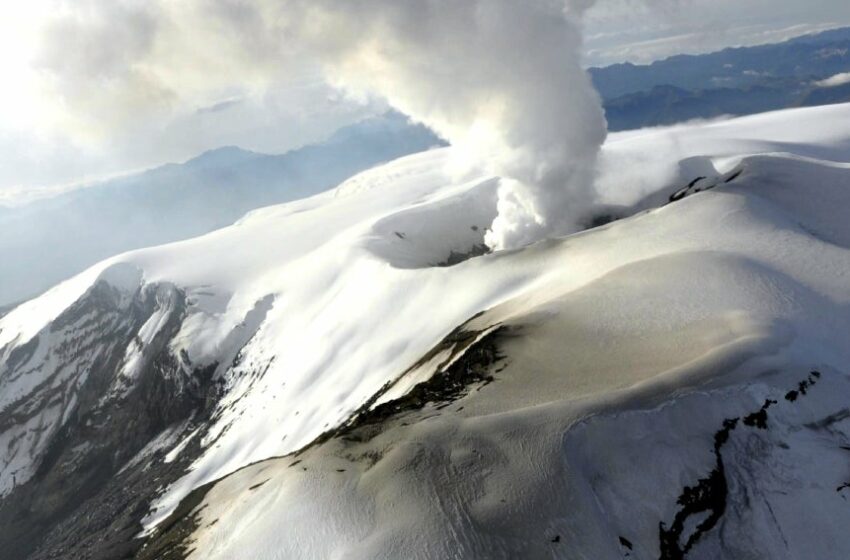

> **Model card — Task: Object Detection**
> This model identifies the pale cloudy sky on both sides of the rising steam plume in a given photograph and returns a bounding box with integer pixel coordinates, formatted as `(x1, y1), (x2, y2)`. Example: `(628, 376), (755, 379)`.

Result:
(0, 0), (850, 199)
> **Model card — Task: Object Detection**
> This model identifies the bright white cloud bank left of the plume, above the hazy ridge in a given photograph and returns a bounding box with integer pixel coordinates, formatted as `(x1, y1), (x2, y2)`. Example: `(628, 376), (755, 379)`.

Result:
(0, 0), (386, 190)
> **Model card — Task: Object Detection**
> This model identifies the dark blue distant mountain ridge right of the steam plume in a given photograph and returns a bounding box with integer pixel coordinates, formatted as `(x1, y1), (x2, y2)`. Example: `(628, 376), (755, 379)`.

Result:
(589, 28), (850, 131)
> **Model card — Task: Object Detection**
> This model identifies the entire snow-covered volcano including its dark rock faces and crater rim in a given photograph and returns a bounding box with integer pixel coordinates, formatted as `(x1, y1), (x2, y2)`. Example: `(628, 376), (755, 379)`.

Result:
(0, 106), (850, 558)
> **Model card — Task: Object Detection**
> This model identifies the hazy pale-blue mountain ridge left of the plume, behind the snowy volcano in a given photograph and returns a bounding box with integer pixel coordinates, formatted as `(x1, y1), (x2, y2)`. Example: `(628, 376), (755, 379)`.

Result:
(0, 113), (442, 306)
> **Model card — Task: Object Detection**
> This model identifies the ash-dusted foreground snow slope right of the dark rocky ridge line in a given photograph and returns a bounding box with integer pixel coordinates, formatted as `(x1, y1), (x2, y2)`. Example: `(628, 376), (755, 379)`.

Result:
(169, 152), (850, 558)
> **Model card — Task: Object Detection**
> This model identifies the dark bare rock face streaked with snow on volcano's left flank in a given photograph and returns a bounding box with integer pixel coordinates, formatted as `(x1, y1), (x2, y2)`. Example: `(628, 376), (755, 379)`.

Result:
(0, 281), (222, 559)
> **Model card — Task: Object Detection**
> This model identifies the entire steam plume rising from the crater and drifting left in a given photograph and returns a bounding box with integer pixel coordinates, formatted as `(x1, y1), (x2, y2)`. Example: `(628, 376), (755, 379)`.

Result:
(36, 0), (606, 249)
